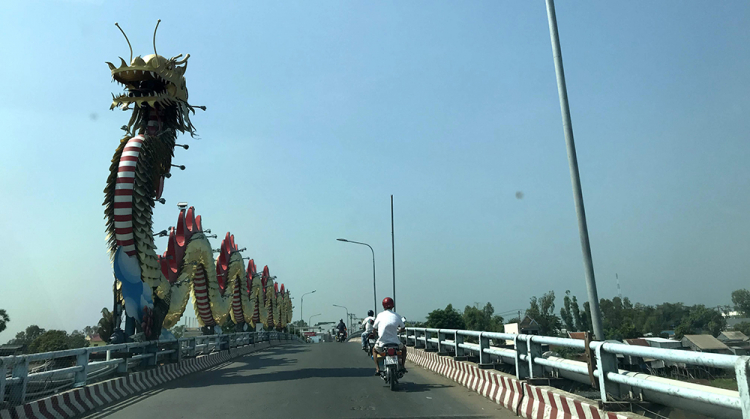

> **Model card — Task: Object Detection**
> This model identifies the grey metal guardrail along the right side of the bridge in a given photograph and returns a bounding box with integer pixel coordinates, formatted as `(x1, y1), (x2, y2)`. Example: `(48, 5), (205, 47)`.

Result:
(401, 327), (750, 419)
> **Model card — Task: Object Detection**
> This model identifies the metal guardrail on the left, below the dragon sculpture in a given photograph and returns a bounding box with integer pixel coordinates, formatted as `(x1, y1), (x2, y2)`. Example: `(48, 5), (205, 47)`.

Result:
(0, 331), (299, 407)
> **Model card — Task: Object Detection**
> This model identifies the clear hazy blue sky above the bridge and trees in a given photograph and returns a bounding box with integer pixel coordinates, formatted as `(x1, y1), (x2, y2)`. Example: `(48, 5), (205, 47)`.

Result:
(0, 0), (750, 341)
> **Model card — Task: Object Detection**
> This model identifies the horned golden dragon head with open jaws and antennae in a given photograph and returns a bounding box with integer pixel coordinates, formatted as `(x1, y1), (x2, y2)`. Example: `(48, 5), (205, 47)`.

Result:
(107, 20), (206, 134)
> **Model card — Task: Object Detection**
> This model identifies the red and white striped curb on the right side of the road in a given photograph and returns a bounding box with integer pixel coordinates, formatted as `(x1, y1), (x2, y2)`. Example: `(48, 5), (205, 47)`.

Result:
(406, 347), (642, 419)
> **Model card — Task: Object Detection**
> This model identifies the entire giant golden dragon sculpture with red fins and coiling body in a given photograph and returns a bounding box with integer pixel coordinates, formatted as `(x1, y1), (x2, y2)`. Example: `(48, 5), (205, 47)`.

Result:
(104, 21), (292, 342)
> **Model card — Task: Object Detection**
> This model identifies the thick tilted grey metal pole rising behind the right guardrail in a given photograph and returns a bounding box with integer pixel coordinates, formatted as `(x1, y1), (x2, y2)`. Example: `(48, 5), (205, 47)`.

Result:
(547, 0), (604, 340)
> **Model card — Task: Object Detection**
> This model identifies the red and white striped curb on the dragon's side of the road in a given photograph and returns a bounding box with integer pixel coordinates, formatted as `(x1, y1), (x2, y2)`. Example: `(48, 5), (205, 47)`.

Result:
(0, 341), (284, 419)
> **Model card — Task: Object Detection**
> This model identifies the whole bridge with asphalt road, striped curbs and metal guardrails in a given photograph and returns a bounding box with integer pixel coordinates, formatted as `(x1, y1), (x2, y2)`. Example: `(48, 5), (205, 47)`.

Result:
(0, 328), (750, 419)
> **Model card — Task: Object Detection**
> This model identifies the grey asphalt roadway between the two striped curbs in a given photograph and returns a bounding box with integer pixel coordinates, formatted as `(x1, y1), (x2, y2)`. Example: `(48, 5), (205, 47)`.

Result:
(85, 342), (517, 419)
